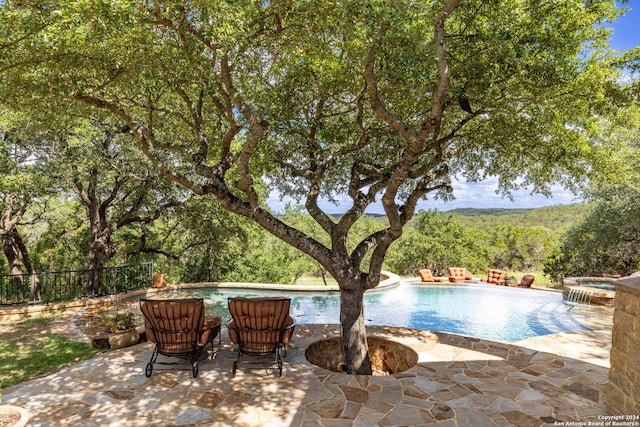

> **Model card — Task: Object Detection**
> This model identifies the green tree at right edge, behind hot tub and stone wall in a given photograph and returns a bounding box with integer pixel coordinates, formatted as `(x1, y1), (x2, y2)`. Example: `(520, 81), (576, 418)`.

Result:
(544, 83), (640, 282)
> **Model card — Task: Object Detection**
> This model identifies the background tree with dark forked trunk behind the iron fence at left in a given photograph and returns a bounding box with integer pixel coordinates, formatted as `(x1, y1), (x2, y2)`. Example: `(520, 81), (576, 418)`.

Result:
(55, 121), (180, 295)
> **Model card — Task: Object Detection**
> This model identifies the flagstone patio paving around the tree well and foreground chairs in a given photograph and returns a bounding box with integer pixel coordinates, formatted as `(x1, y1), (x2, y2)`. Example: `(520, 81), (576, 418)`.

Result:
(2, 306), (611, 427)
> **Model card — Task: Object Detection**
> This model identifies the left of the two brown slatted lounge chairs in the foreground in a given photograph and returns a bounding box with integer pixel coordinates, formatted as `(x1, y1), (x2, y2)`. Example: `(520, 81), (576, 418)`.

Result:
(140, 298), (220, 378)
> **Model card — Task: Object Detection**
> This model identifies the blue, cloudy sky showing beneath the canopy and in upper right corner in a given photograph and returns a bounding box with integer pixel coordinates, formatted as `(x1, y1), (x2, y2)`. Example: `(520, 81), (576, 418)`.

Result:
(268, 0), (640, 213)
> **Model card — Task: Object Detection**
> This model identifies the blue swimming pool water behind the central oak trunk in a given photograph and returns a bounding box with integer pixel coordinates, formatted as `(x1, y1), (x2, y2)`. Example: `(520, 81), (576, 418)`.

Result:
(166, 283), (584, 342)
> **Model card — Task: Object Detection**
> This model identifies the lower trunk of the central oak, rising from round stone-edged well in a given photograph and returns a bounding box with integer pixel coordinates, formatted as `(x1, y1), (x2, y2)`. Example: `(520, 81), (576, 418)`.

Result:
(340, 283), (371, 375)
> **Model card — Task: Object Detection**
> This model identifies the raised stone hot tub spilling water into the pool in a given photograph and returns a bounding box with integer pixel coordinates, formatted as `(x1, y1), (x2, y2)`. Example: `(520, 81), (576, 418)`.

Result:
(562, 277), (617, 306)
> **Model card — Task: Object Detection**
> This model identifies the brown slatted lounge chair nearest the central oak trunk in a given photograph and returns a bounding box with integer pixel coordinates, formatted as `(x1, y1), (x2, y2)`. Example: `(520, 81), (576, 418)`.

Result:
(227, 297), (296, 377)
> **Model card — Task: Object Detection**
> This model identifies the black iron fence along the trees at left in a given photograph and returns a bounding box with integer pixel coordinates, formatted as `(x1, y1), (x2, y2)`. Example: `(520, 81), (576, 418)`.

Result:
(0, 262), (153, 305)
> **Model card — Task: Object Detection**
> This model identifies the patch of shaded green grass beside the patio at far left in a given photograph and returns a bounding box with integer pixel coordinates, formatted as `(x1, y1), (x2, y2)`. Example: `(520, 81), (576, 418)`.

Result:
(0, 317), (99, 390)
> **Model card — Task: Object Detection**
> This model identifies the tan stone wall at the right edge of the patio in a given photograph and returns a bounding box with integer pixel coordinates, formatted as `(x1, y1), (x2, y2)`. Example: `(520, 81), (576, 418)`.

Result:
(608, 276), (640, 415)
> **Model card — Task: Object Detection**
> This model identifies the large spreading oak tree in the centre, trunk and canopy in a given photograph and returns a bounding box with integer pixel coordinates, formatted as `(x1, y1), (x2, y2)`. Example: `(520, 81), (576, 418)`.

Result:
(0, 0), (627, 373)
